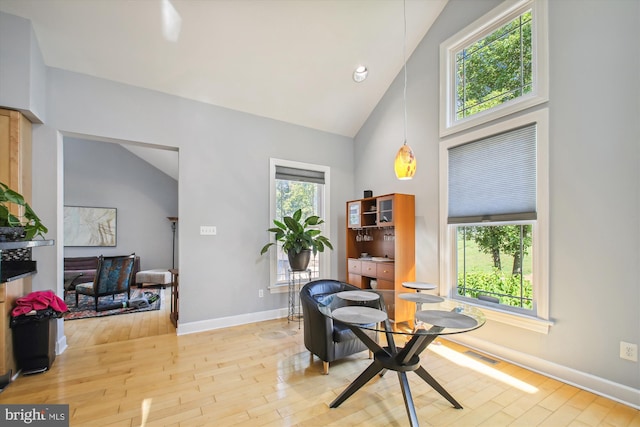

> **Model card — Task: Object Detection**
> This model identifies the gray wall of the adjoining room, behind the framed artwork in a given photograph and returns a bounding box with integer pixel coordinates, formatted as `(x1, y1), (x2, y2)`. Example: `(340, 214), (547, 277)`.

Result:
(64, 137), (179, 270)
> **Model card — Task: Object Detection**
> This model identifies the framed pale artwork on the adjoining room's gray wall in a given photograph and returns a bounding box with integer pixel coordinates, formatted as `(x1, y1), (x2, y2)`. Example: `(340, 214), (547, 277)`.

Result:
(64, 206), (116, 246)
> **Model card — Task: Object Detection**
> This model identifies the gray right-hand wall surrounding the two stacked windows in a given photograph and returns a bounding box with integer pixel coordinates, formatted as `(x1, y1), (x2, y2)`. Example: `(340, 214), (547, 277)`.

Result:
(355, 0), (640, 405)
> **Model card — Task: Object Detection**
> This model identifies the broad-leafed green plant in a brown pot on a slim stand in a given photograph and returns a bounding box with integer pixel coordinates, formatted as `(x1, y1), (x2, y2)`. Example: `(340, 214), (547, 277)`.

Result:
(260, 209), (333, 270)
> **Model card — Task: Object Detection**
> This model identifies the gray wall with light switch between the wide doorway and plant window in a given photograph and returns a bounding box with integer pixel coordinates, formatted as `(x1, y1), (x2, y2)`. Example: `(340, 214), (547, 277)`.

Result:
(40, 69), (353, 324)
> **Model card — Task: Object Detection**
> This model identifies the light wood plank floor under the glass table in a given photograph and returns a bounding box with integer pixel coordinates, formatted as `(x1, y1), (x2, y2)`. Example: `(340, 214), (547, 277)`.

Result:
(0, 288), (640, 427)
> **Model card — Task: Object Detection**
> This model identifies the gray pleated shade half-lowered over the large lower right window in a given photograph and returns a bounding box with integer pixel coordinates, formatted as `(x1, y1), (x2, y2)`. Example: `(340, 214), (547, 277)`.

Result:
(448, 124), (536, 224)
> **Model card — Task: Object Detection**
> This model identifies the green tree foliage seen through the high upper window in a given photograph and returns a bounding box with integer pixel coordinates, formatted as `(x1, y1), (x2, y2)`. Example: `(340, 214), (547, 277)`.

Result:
(456, 11), (533, 119)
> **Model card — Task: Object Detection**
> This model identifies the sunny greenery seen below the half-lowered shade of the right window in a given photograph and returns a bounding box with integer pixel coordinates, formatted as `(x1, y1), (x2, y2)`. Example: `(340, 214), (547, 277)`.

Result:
(458, 225), (533, 309)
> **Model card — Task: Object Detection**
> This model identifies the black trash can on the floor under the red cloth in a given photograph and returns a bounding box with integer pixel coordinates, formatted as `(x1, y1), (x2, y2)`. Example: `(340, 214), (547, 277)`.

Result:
(11, 310), (58, 374)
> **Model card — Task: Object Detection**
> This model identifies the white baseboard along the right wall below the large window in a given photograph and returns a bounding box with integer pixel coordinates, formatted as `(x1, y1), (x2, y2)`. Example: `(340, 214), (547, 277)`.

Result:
(443, 335), (640, 409)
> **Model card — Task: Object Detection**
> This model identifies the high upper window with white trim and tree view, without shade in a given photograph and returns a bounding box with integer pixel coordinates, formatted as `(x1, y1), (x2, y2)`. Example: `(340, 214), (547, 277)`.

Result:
(440, 0), (548, 136)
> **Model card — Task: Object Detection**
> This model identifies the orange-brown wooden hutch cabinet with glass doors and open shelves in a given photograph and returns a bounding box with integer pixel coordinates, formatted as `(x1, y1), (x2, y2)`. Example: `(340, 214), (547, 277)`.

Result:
(347, 194), (415, 322)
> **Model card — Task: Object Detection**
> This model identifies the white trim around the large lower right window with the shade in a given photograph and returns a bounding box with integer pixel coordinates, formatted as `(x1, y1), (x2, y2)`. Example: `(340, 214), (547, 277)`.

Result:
(439, 108), (553, 333)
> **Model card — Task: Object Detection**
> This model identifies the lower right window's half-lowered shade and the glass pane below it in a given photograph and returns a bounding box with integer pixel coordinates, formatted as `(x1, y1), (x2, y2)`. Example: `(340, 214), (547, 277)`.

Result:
(447, 124), (537, 314)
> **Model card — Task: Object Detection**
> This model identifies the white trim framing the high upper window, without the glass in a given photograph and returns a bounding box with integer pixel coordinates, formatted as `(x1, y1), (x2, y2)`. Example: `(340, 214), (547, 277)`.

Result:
(440, 0), (549, 137)
